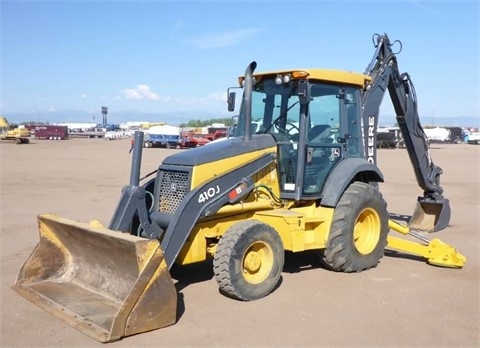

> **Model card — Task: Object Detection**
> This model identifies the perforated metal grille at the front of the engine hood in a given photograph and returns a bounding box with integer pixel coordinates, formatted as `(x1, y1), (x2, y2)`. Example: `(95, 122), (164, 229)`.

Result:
(158, 169), (189, 214)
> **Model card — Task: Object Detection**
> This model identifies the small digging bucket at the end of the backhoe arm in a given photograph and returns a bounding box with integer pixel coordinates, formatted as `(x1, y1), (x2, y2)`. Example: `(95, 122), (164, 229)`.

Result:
(408, 197), (450, 232)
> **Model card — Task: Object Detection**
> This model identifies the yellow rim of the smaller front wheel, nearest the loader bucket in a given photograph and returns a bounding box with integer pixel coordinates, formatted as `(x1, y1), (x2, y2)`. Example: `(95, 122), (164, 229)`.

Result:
(242, 241), (274, 284)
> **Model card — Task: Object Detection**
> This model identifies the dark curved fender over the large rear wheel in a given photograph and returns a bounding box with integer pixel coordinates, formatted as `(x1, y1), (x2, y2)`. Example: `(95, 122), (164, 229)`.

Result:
(320, 157), (384, 208)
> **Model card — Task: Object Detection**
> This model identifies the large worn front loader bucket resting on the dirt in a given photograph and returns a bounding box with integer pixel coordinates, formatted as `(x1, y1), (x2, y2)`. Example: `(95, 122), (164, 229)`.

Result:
(13, 215), (177, 342)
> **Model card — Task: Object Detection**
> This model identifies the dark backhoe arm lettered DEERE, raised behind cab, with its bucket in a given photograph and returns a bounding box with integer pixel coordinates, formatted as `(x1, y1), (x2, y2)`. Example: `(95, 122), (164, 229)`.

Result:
(362, 34), (450, 231)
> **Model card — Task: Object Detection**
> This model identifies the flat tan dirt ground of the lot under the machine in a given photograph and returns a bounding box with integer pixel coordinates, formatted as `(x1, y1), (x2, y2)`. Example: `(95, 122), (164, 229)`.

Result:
(0, 139), (480, 347)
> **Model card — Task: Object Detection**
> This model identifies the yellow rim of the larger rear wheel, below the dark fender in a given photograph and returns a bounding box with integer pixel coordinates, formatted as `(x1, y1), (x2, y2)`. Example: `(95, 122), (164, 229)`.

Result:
(353, 208), (381, 255)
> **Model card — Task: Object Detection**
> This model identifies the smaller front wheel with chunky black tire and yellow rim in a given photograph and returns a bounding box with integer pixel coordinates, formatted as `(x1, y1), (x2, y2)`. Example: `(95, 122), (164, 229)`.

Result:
(213, 220), (285, 301)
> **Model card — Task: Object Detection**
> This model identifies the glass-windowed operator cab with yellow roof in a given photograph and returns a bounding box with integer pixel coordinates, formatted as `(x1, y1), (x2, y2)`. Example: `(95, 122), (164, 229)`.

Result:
(231, 70), (364, 200)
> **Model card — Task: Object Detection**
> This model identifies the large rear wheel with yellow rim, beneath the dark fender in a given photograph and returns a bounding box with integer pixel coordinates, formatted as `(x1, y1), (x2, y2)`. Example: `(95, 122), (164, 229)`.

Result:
(323, 182), (389, 273)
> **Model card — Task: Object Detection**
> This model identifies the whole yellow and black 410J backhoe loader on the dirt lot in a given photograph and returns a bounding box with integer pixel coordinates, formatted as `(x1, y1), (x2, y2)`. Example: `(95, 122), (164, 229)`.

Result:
(13, 35), (466, 342)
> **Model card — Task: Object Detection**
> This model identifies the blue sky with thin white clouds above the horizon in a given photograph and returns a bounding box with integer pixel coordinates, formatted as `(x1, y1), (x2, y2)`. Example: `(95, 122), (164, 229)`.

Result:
(0, 0), (480, 123)
